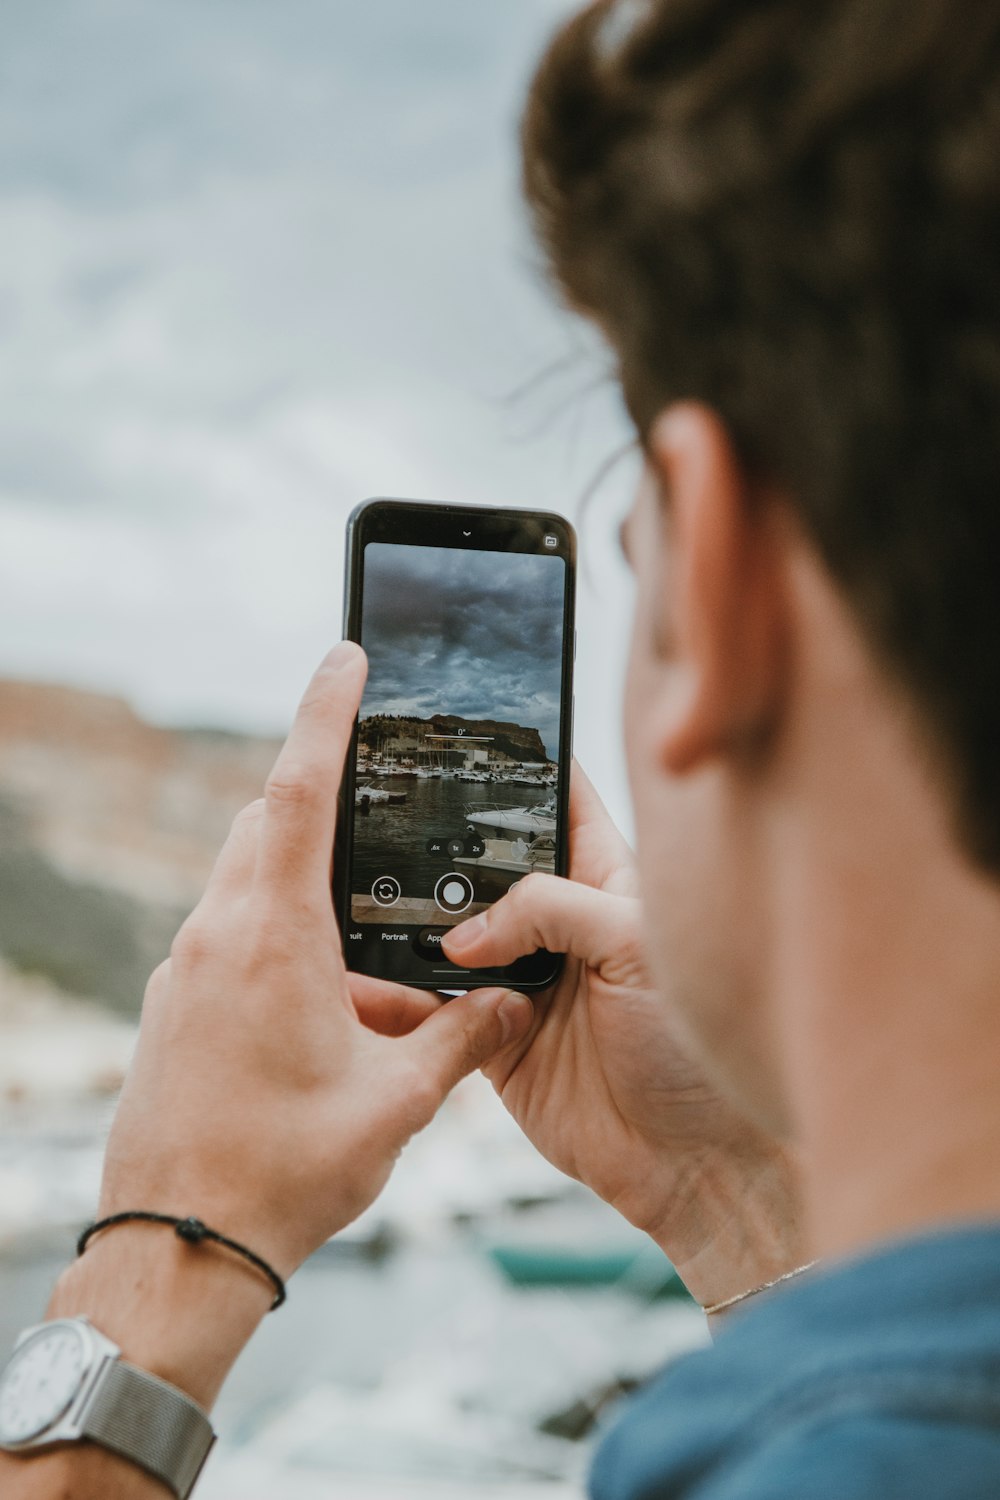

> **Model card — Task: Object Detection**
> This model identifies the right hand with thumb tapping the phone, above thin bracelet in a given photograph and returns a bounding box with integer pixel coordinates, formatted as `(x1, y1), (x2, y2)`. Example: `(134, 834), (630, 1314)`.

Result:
(442, 765), (808, 1304)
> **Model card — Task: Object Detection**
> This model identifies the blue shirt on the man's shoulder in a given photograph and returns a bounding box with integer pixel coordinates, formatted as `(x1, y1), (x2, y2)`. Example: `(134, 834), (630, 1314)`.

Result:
(591, 1226), (1000, 1500)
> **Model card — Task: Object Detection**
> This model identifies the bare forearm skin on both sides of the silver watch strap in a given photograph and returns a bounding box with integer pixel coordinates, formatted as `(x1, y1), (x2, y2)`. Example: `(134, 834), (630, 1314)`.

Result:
(0, 1224), (273, 1500)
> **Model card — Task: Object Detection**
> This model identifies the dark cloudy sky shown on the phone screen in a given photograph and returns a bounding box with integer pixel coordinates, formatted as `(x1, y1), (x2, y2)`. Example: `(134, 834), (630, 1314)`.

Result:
(361, 542), (565, 761)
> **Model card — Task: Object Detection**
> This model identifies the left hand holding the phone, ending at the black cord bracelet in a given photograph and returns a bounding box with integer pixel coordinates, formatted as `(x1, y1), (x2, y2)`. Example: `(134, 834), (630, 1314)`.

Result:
(100, 642), (531, 1275)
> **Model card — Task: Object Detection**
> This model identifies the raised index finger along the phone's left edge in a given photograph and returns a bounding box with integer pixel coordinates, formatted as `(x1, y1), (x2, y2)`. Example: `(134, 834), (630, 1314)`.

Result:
(256, 641), (367, 890)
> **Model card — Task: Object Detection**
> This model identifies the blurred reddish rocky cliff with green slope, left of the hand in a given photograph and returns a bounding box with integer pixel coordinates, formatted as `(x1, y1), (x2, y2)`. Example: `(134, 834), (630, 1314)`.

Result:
(0, 681), (277, 1011)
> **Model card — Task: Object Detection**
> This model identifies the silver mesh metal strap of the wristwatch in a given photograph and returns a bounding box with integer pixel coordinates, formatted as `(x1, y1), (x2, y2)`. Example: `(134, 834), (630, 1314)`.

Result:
(82, 1359), (216, 1500)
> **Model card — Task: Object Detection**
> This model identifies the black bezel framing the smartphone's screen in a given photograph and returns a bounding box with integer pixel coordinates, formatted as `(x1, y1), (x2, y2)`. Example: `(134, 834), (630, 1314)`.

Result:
(333, 498), (576, 992)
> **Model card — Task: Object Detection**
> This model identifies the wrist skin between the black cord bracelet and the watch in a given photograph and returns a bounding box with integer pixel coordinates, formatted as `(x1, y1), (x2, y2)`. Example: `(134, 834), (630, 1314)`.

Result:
(46, 1224), (273, 1410)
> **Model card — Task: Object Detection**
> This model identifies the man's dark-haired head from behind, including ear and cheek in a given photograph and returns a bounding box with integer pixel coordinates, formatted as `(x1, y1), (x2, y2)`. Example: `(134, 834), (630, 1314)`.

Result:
(523, 0), (1000, 1128)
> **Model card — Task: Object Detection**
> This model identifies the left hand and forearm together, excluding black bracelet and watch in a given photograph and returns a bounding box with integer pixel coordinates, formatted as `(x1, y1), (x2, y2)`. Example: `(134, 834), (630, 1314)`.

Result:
(0, 642), (532, 1500)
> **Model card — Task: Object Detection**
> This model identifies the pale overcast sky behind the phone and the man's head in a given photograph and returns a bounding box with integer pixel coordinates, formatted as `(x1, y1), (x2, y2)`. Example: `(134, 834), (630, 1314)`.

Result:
(0, 0), (638, 816)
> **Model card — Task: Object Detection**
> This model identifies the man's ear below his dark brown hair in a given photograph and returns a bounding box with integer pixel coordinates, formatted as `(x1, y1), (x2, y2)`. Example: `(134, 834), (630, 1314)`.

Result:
(648, 402), (786, 776)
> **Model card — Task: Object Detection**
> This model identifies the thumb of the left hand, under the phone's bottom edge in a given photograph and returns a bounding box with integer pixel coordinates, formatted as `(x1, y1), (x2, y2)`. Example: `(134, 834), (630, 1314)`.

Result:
(393, 990), (534, 1109)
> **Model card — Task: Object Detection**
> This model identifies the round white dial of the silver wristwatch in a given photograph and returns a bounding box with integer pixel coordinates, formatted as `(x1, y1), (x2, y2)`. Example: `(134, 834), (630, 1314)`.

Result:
(0, 1322), (87, 1443)
